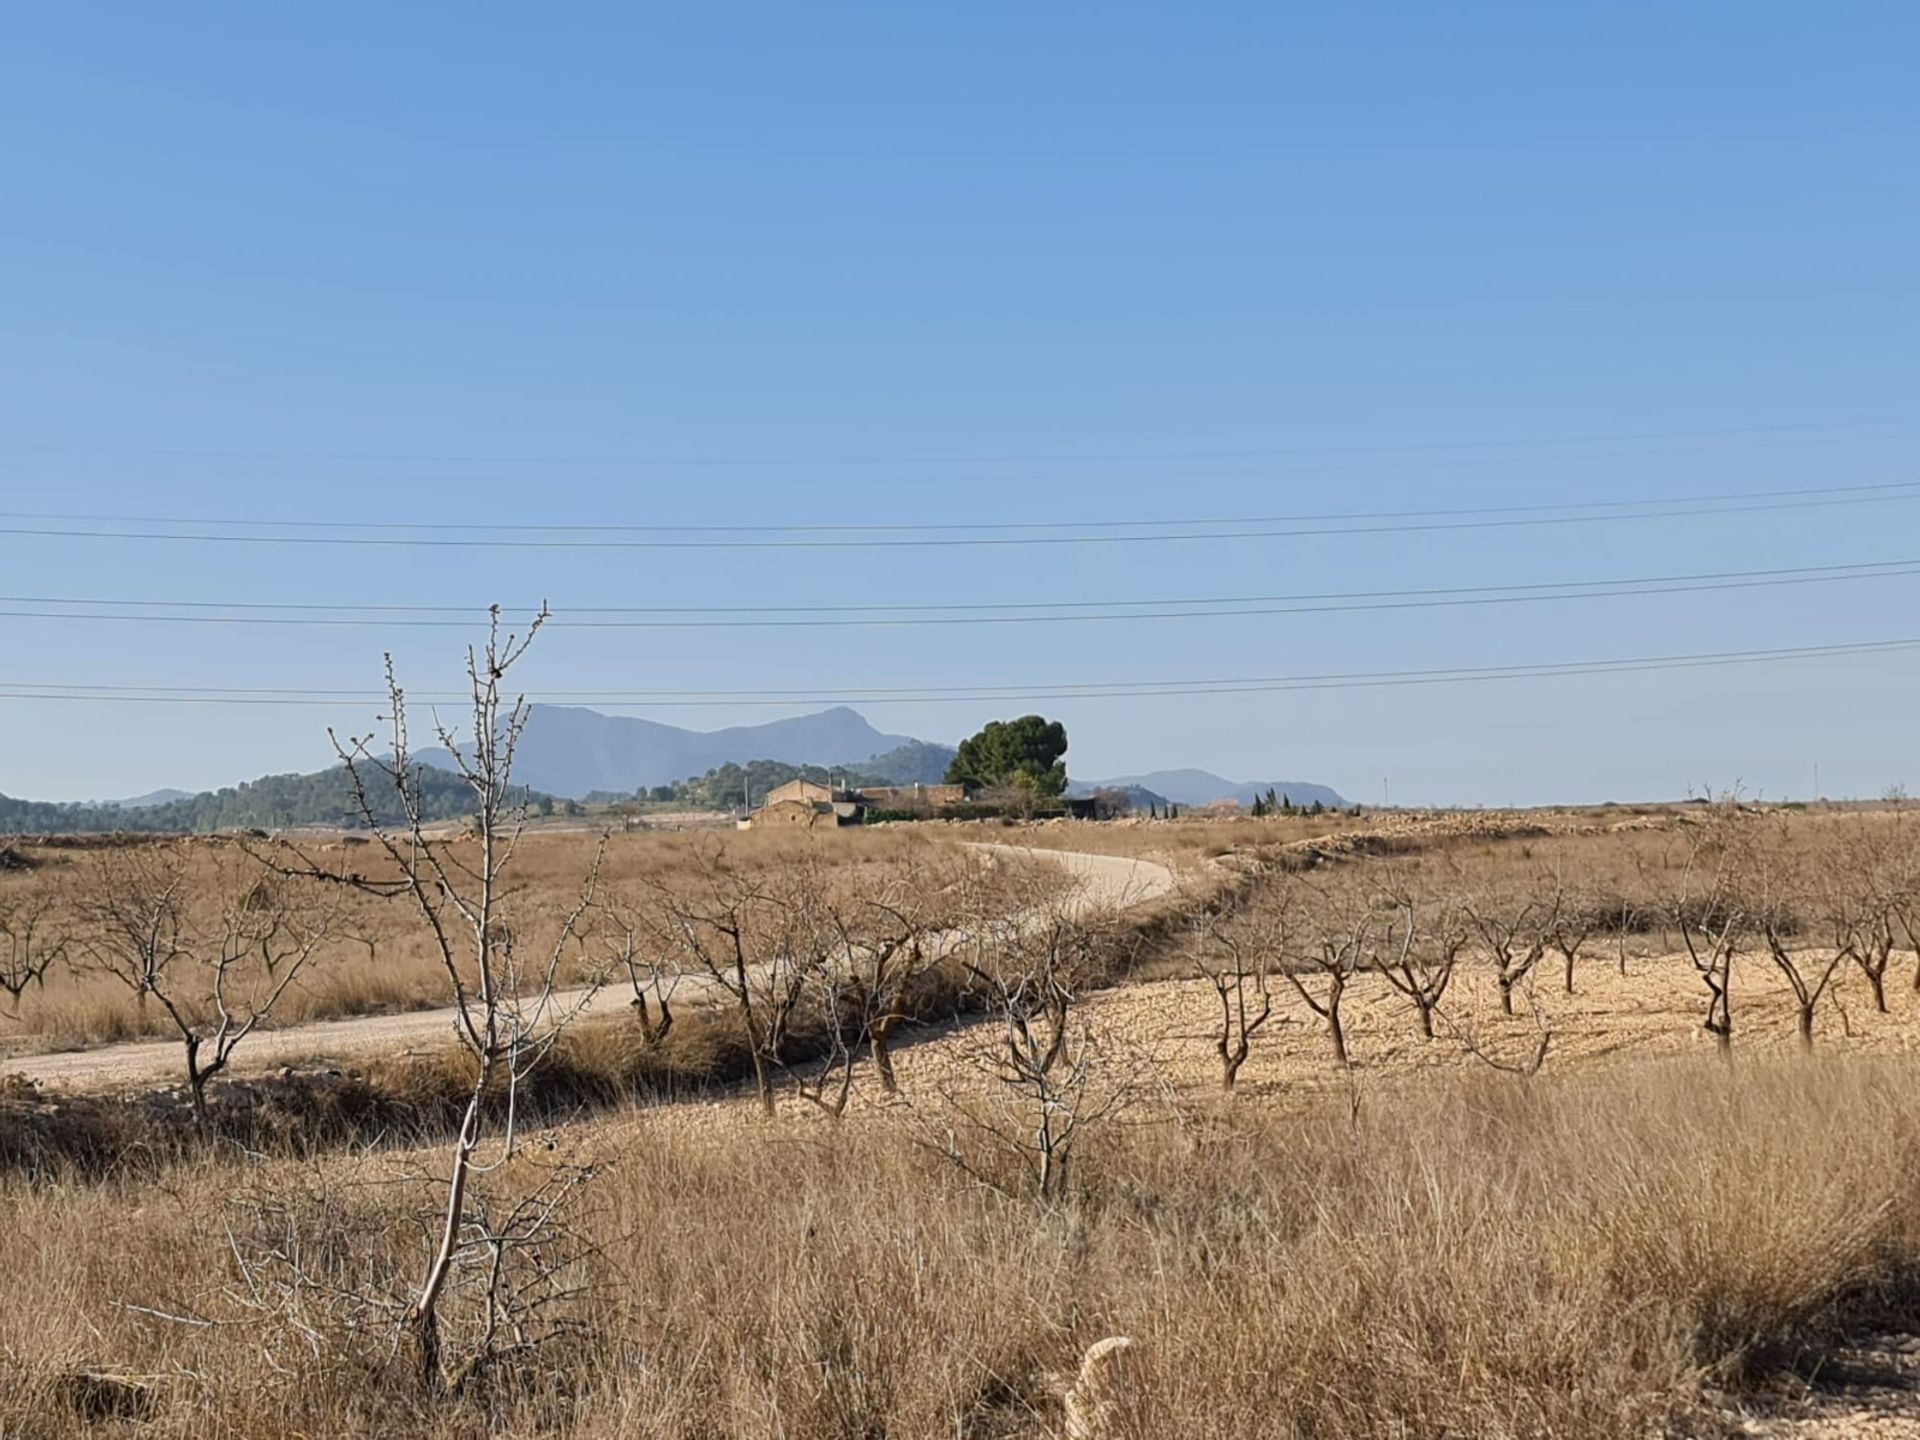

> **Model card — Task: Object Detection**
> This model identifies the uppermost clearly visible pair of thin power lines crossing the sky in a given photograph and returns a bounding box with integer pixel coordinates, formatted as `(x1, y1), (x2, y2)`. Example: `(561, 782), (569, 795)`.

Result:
(0, 480), (1920, 551)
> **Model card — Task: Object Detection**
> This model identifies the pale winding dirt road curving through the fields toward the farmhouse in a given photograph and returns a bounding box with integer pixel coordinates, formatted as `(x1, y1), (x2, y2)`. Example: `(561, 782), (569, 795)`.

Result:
(0, 845), (1175, 1091)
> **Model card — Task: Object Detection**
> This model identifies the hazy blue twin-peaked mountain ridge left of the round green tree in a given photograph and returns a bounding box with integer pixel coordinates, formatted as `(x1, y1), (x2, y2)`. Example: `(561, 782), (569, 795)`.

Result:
(415, 705), (921, 801)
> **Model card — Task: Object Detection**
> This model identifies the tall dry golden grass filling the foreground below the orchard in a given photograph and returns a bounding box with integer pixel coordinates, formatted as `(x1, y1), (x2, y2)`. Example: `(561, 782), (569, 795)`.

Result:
(0, 1058), (1920, 1440)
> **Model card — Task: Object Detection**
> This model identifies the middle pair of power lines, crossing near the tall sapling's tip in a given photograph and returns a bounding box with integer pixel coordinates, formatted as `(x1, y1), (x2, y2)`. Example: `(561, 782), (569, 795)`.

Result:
(0, 559), (1920, 630)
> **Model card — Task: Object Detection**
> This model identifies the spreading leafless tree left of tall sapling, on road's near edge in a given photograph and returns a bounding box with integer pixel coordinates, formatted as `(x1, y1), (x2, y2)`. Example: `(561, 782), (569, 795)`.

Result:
(81, 841), (334, 1127)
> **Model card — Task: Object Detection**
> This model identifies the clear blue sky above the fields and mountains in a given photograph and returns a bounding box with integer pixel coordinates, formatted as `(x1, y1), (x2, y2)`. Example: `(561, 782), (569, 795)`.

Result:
(0, 4), (1920, 803)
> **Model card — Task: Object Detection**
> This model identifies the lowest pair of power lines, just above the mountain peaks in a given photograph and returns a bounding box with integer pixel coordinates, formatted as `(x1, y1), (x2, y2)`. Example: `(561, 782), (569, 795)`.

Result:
(0, 637), (1920, 708)
